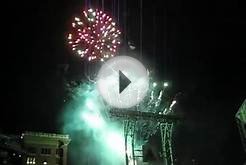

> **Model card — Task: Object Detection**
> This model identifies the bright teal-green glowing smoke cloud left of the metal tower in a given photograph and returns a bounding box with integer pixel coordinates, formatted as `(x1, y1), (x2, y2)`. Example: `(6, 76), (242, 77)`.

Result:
(63, 80), (125, 165)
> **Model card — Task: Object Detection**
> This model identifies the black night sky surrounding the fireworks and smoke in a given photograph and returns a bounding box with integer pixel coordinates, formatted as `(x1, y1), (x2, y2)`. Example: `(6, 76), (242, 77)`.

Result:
(0, 0), (246, 165)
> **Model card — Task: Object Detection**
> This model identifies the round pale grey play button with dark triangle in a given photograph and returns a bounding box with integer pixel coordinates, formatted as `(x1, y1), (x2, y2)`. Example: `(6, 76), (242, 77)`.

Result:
(97, 56), (149, 108)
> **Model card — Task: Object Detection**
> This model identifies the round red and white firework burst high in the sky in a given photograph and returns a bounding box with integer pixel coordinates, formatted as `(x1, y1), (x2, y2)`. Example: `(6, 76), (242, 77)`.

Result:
(67, 9), (121, 61)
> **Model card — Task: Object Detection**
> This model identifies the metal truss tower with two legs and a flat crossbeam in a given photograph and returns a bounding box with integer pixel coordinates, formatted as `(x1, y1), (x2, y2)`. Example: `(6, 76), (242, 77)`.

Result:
(109, 109), (180, 165)
